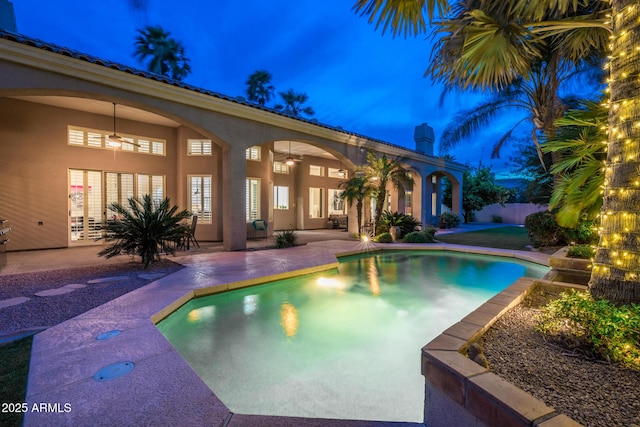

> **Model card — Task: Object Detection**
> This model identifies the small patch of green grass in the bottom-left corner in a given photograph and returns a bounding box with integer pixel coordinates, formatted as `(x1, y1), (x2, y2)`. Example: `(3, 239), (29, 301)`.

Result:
(0, 337), (33, 426)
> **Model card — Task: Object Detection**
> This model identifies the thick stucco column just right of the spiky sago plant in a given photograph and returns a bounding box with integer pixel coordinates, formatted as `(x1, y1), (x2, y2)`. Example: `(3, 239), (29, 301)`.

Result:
(222, 146), (247, 251)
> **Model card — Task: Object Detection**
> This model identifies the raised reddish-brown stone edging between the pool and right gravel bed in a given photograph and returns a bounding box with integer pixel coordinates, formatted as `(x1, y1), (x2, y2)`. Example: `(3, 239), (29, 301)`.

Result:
(421, 278), (584, 427)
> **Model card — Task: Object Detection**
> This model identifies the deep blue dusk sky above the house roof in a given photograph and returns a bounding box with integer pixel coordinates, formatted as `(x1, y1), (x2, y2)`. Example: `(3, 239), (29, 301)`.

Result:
(6, 0), (576, 175)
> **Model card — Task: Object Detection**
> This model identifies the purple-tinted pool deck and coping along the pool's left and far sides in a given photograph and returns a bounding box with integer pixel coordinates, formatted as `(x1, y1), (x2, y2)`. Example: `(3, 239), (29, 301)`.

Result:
(24, 241), (548, 426)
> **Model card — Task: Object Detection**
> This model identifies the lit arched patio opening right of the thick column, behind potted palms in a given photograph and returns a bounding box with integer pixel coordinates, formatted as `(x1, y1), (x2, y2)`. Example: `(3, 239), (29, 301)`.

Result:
(246, 138), (355, 234)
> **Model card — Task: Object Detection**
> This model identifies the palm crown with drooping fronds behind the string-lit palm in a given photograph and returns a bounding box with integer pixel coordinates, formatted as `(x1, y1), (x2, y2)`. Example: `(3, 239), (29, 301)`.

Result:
(427, 0), (609, 169)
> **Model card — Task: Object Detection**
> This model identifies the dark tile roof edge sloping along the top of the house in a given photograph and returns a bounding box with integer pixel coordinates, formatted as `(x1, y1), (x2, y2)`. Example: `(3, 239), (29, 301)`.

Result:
(0, 28), (440, 157)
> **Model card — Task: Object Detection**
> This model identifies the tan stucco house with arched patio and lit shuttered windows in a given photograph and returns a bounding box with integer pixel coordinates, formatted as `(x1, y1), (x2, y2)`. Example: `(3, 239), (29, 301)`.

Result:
(0, 30), (465, 250)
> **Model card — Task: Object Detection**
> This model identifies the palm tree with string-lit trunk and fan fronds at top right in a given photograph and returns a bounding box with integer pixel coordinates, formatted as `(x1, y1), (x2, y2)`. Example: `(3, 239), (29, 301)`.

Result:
(354, 0), (640, 304)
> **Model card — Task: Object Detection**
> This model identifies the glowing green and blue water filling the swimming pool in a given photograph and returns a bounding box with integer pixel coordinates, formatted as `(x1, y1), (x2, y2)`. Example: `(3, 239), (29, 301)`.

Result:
(158, 251), (548, 422)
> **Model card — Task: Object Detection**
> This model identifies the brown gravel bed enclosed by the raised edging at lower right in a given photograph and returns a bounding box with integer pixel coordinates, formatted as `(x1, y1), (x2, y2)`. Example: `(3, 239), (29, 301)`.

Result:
(481, 288), (640, 427)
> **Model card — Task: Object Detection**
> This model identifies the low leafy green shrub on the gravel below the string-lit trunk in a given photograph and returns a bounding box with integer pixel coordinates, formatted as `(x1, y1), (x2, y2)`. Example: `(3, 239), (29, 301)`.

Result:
(537, 290), (640, 369)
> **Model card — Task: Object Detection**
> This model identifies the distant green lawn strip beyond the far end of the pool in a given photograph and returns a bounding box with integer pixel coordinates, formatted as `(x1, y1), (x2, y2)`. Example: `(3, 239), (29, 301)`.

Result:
(436, 226), (531, 251)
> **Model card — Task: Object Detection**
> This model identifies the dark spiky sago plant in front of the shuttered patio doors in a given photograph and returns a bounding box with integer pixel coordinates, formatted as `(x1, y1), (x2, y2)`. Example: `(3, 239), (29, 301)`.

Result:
(98, 194), (191, 268)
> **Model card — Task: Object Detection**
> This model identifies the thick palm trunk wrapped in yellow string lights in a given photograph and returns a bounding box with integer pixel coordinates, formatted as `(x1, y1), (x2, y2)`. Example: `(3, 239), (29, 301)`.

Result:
(589, 0), (640, 304)
